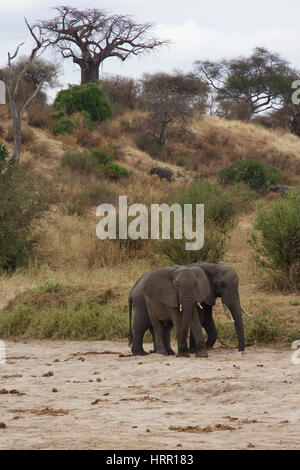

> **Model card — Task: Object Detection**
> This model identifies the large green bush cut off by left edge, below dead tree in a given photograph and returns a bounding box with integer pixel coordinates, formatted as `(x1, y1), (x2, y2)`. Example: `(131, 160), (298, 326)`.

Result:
(0, 159), (48, 272)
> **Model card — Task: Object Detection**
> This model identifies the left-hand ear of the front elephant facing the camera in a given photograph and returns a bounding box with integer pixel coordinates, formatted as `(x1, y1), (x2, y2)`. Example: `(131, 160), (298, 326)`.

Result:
(144, 268), (178, 307)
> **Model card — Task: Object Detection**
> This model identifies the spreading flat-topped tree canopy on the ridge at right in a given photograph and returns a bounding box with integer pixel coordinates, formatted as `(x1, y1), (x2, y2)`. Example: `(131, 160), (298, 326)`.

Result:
(195, 47), (299, 115)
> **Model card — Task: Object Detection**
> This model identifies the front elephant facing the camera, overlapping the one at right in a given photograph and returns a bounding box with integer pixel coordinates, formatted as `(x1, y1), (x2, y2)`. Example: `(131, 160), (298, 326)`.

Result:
(128, 266), (210, 357)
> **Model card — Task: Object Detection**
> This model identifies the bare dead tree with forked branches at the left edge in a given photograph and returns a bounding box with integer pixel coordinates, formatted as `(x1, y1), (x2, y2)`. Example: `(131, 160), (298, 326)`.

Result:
(0, 18), (45, 161)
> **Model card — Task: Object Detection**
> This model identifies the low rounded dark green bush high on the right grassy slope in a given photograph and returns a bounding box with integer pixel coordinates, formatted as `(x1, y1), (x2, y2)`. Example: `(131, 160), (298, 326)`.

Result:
(219, 160), (283, 191)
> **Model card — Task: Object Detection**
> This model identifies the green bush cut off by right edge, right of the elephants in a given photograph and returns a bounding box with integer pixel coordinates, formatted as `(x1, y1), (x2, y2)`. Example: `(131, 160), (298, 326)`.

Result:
(249, 190), (300, 289)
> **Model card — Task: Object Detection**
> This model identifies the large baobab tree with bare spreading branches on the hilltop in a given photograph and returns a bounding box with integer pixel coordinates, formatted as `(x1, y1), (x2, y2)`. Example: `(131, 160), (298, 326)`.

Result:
(37, 6), (169, 85)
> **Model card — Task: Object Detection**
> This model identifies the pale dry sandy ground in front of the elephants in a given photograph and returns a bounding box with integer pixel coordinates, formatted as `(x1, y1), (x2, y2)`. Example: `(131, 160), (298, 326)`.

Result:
(0, 340), (300, 450)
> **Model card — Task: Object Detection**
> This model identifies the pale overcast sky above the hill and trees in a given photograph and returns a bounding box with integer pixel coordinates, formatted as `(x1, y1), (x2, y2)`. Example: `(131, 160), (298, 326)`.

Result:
(0, 0), (300, 99)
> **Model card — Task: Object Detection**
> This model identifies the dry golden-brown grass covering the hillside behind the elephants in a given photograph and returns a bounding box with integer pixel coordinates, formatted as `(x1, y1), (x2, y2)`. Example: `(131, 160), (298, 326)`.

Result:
(0, 106), (300, 342)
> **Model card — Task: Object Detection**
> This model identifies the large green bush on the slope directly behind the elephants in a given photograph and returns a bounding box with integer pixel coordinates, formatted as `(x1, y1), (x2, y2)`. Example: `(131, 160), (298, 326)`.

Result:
(153, 178), (254, 264)
